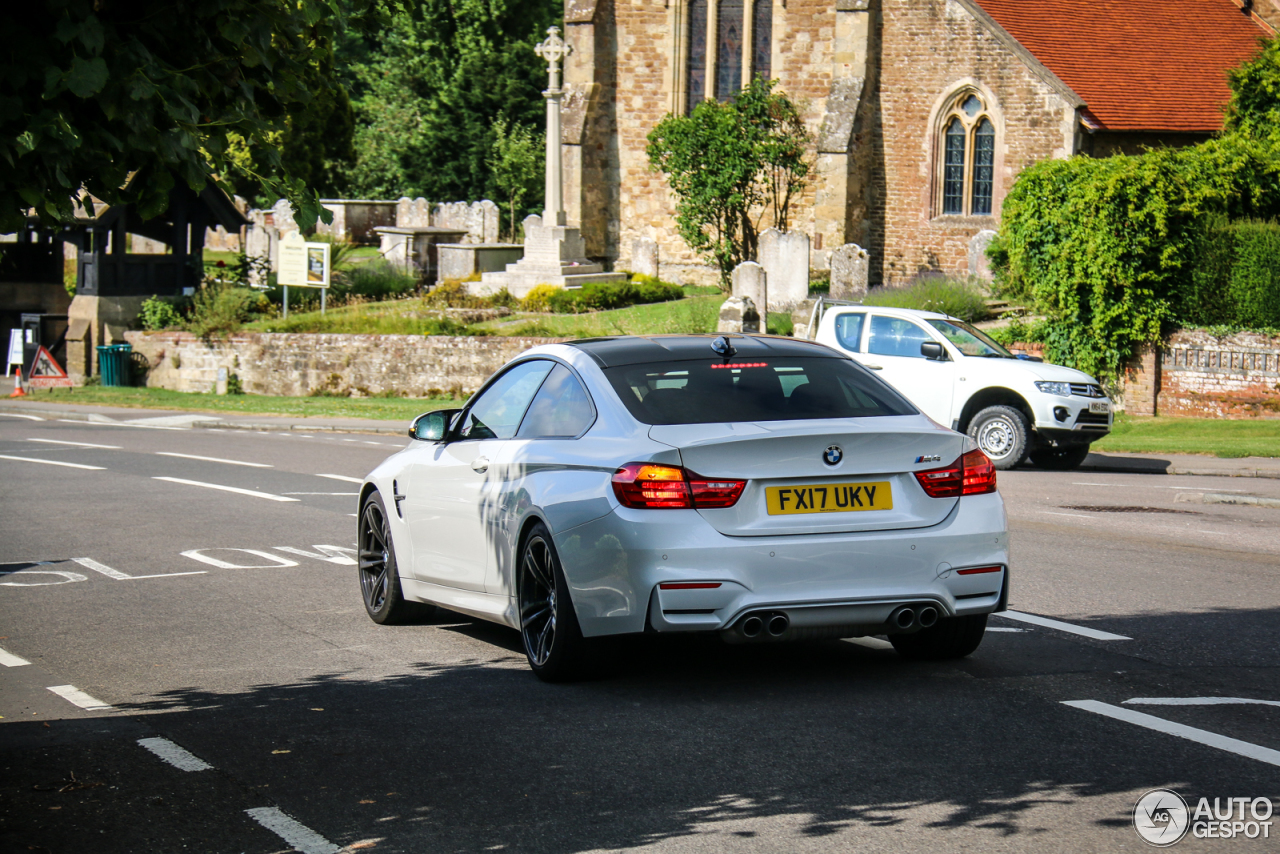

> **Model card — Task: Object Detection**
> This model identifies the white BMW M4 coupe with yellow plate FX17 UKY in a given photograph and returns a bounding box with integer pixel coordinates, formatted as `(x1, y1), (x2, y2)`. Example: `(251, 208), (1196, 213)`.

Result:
(358, 335), (1009, 680)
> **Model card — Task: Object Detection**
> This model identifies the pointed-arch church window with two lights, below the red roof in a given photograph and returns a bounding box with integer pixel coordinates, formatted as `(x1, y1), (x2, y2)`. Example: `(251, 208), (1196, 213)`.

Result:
(937, 90), (996, 216)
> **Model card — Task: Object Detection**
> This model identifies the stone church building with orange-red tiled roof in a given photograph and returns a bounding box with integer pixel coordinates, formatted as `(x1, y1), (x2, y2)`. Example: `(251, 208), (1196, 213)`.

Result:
(562, 0), (1280, 284)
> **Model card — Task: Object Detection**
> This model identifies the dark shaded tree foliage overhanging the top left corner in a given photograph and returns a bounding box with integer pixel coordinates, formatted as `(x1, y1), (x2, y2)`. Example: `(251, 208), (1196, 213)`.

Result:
(0, 0), (378, 230)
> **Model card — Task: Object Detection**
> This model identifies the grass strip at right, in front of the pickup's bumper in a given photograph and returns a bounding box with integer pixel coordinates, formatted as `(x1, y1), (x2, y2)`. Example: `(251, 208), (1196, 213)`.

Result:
(1093, 415), (1280, 457)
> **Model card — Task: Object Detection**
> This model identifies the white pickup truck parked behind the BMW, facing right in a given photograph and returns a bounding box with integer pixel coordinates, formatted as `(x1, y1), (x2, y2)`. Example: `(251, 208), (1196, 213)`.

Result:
(810, 301), (1112, 469)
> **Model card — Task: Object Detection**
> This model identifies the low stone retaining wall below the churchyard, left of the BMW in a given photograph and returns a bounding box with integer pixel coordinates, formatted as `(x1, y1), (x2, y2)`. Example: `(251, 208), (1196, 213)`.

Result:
(125, 332), (562, 397)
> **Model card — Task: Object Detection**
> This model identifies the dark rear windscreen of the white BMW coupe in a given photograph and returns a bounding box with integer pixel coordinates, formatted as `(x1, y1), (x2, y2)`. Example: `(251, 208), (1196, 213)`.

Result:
(604, 359), (916, 424)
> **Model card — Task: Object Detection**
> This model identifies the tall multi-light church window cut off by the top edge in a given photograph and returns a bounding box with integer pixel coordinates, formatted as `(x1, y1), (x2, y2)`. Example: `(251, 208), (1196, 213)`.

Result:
(677, 0), (774, 113)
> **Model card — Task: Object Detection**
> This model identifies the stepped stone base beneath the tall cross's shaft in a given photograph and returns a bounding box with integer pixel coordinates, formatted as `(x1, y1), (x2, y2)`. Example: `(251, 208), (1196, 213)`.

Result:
(471, 215), (627, 297)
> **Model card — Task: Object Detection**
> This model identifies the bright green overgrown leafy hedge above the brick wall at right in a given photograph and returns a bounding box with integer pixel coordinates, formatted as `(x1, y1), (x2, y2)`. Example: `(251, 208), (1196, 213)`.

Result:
(989, 136), (1280, 379)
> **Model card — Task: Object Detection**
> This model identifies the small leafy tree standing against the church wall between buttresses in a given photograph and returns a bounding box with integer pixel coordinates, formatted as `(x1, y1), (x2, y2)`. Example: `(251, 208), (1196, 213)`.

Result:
(646, 78), (810, 289)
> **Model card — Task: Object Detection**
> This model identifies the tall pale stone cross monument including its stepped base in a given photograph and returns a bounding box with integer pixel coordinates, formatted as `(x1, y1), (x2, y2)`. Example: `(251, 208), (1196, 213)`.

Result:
(475, 27), (627, 297)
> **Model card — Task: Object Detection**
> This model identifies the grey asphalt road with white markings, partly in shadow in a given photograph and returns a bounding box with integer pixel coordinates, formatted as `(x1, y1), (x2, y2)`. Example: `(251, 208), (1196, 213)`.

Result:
(0, 416), (1280, 854)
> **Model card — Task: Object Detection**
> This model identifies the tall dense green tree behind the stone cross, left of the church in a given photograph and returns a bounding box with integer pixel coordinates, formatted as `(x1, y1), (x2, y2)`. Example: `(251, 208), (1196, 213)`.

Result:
(338, 0), (563, 201)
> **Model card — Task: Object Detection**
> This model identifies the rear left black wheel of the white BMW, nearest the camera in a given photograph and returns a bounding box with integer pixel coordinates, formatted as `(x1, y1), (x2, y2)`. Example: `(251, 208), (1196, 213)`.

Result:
(517, 522), (591, 682)
